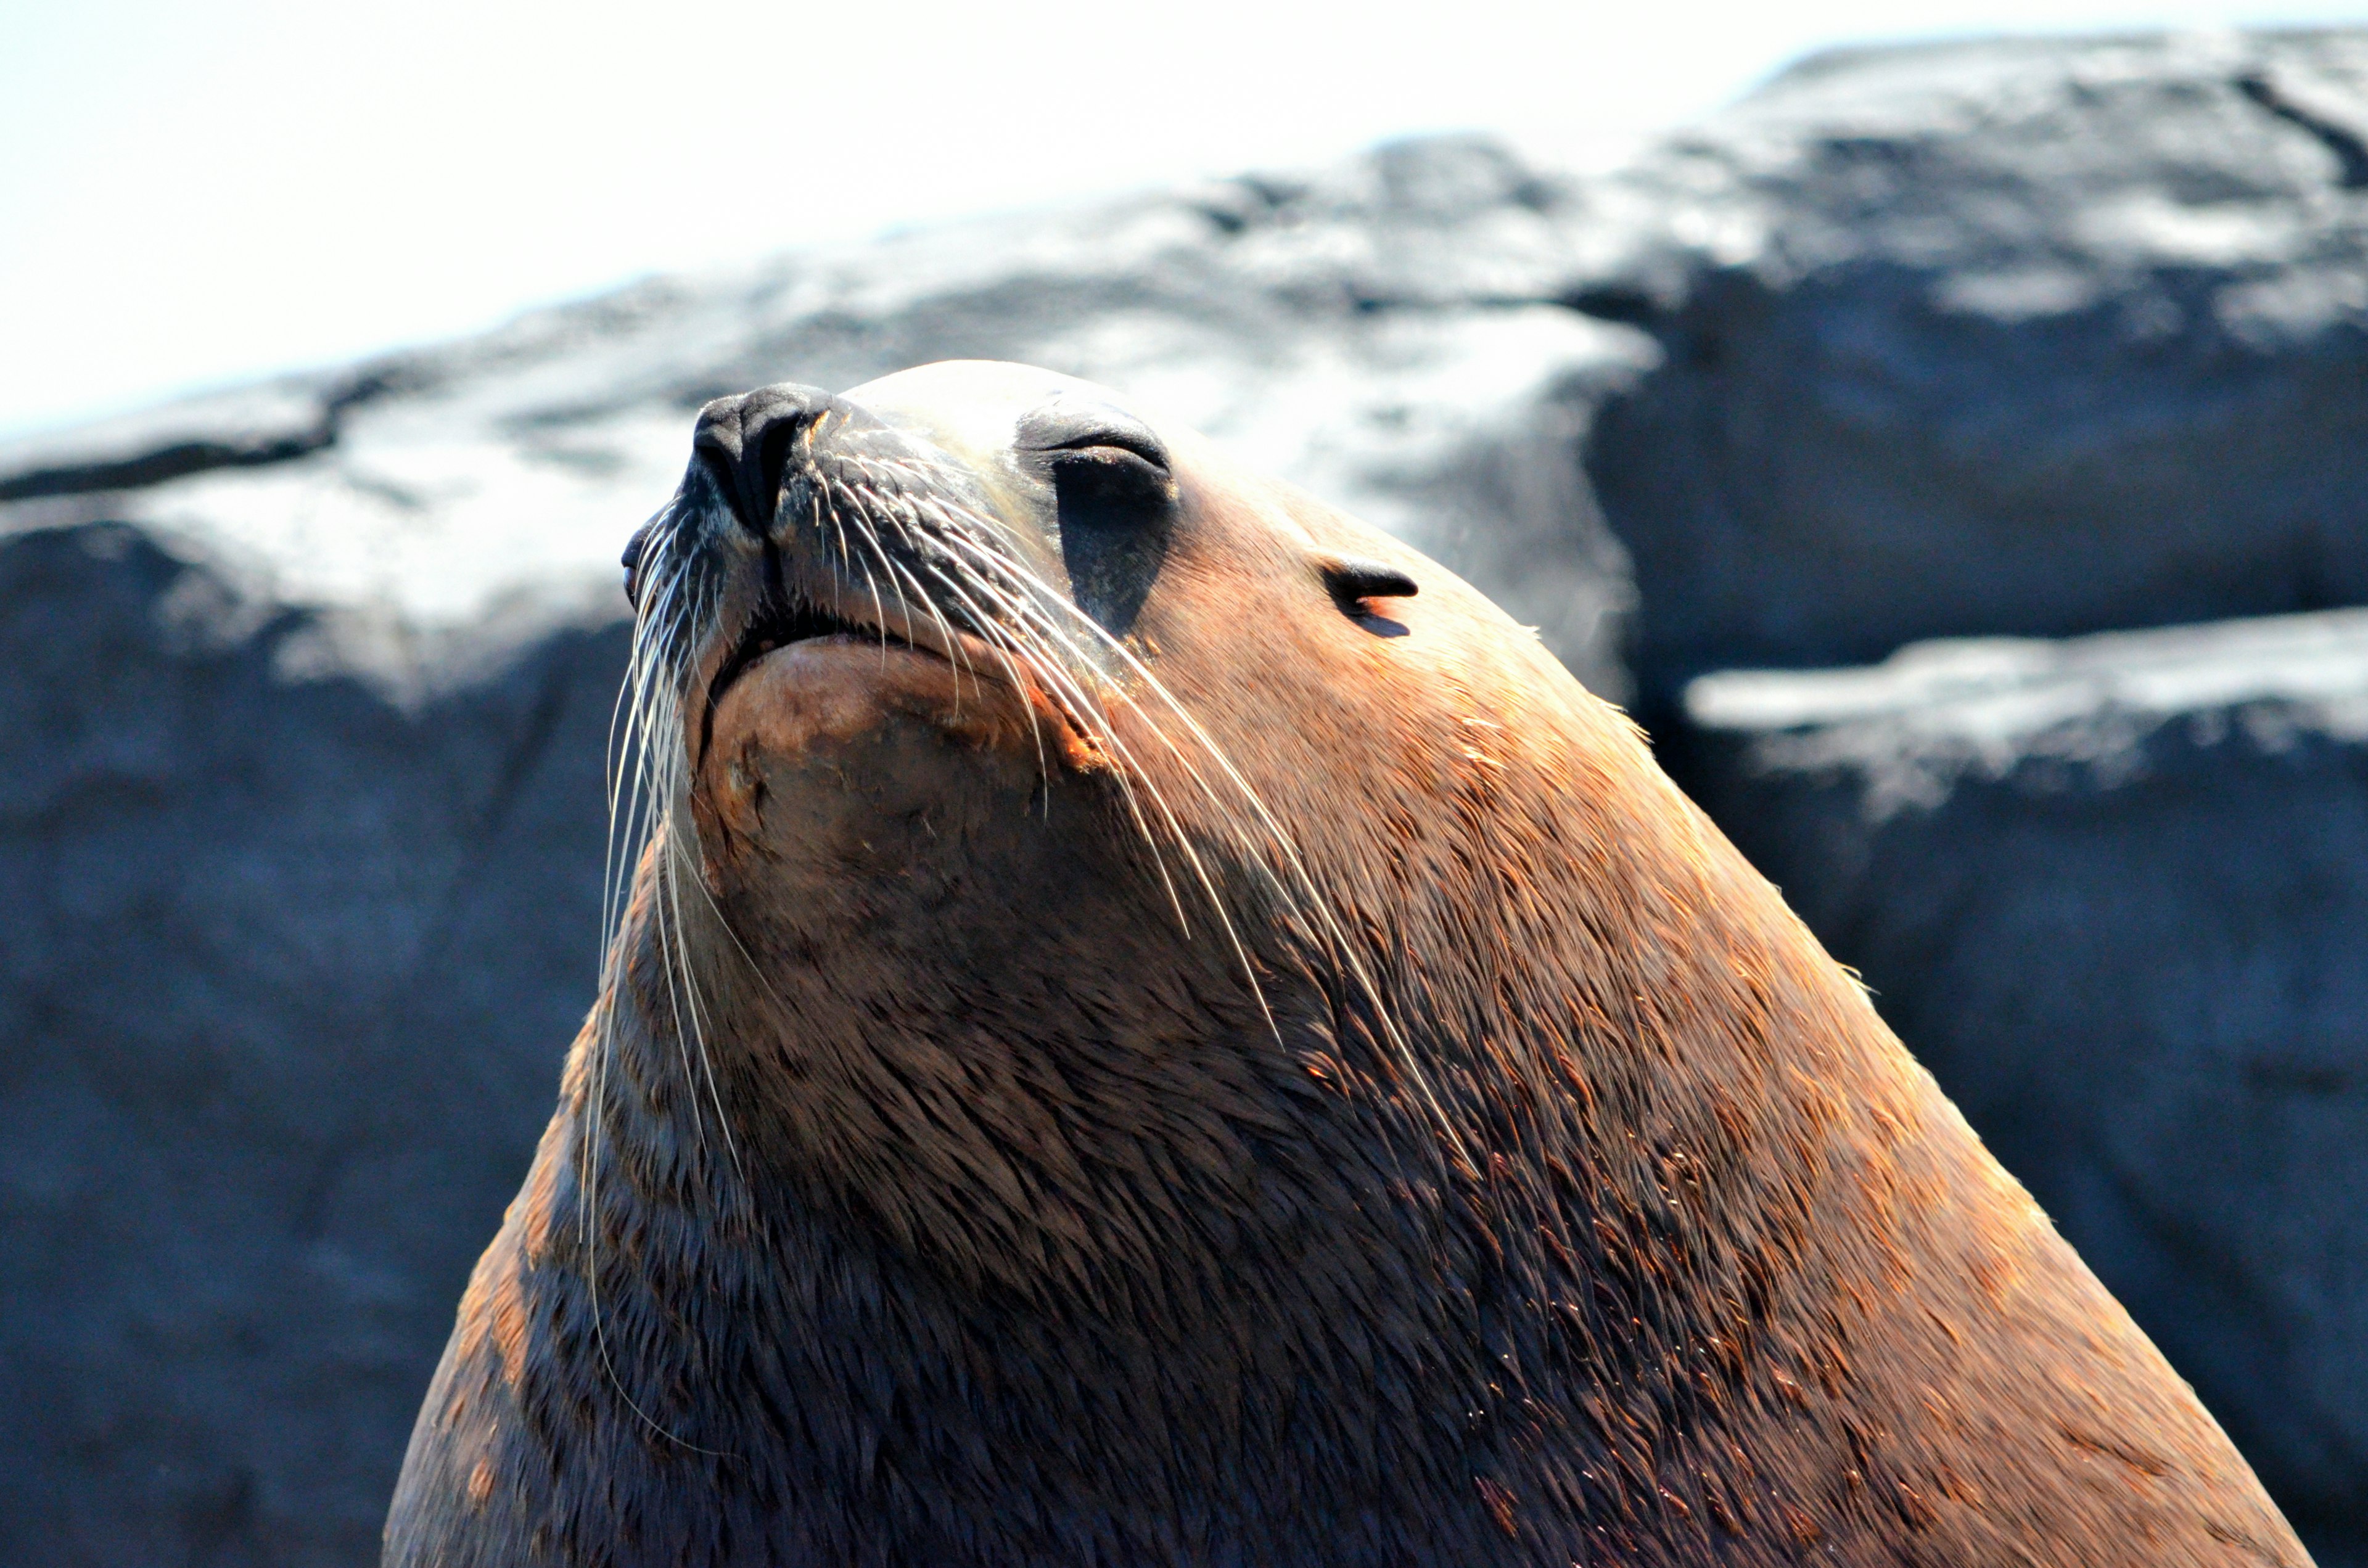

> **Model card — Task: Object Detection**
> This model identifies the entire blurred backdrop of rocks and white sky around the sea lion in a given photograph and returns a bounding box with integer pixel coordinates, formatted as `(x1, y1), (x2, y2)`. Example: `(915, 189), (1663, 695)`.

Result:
(0, 0), (2368, 1566)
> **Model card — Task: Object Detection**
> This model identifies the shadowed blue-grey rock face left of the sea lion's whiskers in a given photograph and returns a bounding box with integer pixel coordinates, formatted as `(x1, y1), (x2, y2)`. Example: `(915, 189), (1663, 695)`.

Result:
(0, 526), (623, 1566)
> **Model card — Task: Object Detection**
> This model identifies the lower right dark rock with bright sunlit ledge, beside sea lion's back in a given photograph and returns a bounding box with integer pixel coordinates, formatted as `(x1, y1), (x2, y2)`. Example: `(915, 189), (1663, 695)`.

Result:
(1684, 609), (2368, 1563)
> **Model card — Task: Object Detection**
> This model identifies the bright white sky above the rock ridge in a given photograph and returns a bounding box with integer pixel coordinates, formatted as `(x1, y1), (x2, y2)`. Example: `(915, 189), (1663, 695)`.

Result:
(0, 0), (2368, 431)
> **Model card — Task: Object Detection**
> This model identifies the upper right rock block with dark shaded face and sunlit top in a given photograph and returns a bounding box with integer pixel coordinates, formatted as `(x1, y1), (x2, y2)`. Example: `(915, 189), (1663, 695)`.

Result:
(1587, 31), (2368, 704)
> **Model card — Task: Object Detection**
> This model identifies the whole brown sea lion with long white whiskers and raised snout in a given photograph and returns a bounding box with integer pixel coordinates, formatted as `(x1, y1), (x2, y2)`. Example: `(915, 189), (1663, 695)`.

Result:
(386, 363), (2306, 1568)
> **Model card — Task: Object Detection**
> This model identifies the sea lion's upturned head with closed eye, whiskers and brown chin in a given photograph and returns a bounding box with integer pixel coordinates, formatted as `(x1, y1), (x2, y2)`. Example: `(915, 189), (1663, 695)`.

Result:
(628, 363), (1624, 1279)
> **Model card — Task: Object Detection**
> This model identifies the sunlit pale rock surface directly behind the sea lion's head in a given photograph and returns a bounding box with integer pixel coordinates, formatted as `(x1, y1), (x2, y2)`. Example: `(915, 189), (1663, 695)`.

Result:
(0, 140), (1658, 696)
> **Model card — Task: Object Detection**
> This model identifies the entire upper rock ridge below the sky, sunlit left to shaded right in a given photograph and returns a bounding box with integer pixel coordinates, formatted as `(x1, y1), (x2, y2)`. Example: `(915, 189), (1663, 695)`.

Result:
(18, 31), (2368, 715)
